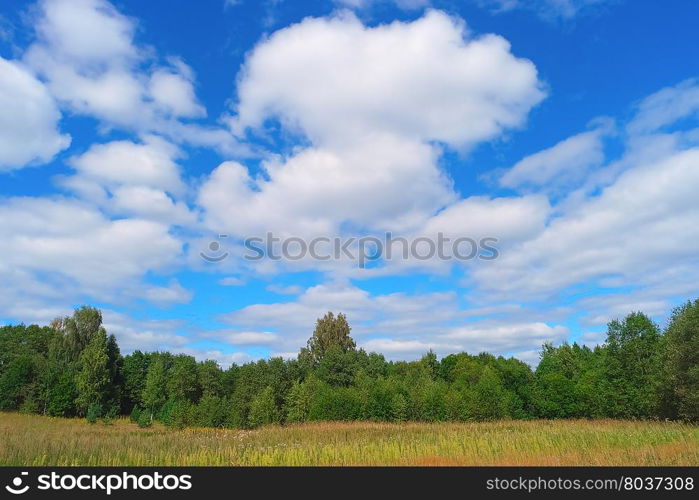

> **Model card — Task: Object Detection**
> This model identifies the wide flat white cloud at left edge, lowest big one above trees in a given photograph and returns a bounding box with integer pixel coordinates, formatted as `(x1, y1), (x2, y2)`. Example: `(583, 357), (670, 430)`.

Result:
(0, 198), (181, 300)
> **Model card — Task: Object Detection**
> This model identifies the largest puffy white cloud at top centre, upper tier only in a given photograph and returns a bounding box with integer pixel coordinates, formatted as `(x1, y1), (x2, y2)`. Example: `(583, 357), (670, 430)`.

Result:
(233, 11), (544, 147)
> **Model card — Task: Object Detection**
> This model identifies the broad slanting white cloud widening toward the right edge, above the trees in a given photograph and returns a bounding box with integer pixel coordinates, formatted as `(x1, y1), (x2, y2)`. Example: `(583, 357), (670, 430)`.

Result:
(474, 148), (699, 294)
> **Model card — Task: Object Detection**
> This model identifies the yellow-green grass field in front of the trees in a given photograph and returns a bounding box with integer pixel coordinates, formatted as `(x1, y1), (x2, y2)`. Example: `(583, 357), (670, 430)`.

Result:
(0, 413), (699, 466)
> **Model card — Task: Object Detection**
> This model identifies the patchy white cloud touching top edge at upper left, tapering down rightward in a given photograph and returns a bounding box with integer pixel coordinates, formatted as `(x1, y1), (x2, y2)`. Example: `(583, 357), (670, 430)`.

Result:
(23, 0), (241, 152)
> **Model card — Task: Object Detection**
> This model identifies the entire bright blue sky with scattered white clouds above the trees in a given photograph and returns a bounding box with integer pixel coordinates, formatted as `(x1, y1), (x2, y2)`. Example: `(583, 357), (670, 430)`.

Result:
(0, 0), (699, 366)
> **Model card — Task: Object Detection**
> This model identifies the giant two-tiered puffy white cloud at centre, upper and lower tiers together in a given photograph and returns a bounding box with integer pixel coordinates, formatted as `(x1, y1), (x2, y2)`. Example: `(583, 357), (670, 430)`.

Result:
(198, 11), (544, 246)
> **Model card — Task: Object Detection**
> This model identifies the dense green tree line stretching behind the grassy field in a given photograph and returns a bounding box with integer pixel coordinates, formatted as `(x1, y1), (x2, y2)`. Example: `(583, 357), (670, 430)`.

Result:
(0, 300), (699, 428)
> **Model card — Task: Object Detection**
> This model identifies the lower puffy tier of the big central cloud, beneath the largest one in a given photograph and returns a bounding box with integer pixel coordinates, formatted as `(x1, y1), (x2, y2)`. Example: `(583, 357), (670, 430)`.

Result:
(198, 136), (455, 236)
